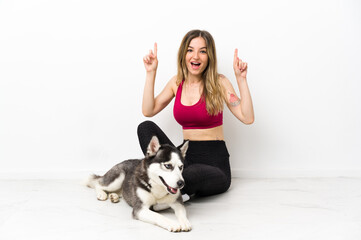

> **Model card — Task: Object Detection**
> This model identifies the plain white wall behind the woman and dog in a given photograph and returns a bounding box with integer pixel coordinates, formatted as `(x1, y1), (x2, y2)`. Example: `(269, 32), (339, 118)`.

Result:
(0, 0), (361, 178)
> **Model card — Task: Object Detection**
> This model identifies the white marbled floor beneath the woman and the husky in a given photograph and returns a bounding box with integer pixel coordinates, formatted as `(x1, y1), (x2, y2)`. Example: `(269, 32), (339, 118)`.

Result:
(0, 178), (361, 240)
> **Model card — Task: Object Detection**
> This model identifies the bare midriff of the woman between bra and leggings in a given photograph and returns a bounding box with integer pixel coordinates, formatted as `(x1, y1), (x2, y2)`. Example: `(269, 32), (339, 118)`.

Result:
(183, 126), (224, 141)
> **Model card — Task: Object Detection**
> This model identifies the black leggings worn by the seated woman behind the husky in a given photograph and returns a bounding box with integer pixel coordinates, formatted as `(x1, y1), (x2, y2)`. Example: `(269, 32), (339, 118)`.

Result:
(138, 121), (231, 196)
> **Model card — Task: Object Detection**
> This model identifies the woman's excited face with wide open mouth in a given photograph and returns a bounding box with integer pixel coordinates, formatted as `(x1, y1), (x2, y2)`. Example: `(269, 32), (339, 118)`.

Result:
(186, 37), (208, 76)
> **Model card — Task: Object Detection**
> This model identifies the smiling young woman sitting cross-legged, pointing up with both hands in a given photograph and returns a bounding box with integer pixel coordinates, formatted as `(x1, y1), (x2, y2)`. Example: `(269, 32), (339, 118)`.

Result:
(138, 30), (254, 200)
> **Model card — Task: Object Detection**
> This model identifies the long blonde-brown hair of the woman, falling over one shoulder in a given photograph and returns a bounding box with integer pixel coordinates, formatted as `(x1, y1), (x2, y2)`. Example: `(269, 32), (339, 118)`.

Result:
(177, 30), (225, 115)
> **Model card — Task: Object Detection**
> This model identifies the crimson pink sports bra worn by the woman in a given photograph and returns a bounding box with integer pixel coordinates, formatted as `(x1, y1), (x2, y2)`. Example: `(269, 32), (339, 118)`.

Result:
(173, 80), (223, 129)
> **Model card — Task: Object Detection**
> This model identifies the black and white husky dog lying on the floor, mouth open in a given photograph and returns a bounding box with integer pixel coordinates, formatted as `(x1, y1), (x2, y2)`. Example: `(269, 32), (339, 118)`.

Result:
(87, 136), (191, 232)
